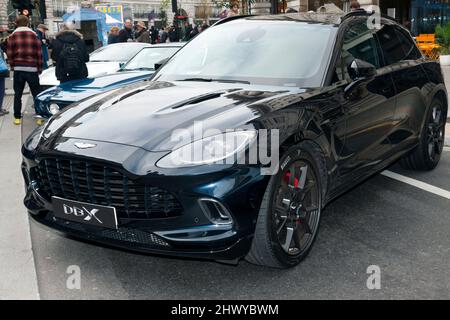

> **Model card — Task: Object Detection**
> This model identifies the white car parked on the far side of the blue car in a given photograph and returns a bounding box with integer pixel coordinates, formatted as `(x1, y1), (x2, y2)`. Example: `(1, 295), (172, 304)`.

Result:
(39, 42), (150, 89)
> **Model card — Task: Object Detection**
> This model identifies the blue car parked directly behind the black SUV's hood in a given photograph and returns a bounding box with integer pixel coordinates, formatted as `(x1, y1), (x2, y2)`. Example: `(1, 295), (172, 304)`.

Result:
(35, 42), (183, 118)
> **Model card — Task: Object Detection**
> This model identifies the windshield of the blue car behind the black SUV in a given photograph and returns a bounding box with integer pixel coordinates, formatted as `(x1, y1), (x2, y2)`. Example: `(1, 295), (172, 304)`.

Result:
(124, 47), (179, 70)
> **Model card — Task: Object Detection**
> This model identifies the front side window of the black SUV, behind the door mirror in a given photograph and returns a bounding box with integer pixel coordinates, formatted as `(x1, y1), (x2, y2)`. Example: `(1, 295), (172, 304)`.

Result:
(333, 20), (381, 82)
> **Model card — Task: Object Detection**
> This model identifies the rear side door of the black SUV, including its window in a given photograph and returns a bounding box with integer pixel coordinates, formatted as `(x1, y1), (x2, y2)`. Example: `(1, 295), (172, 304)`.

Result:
(376, 21), (432, 152)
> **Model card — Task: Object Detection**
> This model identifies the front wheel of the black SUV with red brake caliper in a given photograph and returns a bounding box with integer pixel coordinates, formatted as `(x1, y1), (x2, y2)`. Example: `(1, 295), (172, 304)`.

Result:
(245, 141), (327, 268)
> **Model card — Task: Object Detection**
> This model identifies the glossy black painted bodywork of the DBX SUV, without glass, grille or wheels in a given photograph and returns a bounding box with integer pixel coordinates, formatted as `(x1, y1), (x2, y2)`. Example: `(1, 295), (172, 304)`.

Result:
(22, 13), (447, 260)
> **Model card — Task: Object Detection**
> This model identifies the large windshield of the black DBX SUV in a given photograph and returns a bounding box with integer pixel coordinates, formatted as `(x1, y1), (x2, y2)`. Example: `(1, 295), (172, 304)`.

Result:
(155, 20), (337, 87)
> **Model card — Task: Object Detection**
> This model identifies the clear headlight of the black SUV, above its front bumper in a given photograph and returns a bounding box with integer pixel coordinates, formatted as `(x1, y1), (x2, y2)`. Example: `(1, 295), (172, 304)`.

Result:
(156, 130), (257, 168)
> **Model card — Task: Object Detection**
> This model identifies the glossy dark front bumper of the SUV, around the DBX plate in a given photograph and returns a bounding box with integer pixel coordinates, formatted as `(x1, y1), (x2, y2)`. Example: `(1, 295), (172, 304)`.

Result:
(22, 150), (265, 260)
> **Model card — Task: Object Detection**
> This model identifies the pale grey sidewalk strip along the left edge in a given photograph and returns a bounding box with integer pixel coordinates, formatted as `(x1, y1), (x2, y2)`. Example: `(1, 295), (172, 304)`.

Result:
(0, 95), (39, 300)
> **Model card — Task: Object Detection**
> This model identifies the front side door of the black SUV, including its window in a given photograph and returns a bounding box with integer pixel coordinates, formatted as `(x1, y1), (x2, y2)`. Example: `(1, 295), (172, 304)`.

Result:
(326, 18), (395, 185)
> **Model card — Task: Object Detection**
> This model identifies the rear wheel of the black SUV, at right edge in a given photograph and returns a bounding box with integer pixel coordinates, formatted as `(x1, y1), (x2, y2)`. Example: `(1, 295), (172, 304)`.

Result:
(400, 98), (447, 171)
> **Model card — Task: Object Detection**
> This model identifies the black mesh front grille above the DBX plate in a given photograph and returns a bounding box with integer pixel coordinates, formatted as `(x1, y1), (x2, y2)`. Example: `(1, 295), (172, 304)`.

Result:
(37, 158), (182, 219)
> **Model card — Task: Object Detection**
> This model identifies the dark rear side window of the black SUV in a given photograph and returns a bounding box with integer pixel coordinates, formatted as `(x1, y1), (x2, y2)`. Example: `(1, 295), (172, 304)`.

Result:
(376, 25), (421, 65)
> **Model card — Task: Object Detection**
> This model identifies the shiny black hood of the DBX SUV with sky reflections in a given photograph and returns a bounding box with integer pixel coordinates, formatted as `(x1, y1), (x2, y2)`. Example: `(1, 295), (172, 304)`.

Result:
(44, 81), (306, 151)
